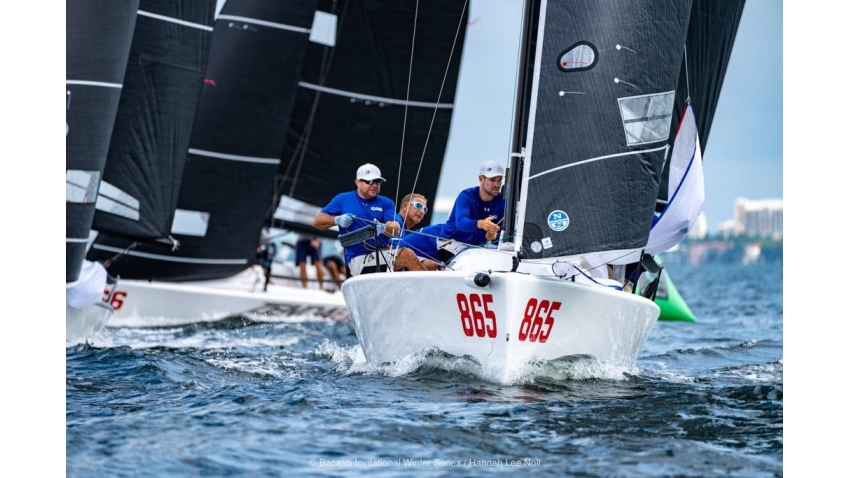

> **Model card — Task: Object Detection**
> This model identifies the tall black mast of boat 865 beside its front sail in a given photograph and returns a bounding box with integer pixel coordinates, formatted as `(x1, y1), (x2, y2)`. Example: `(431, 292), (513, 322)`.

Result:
(500, 0), (540, 251)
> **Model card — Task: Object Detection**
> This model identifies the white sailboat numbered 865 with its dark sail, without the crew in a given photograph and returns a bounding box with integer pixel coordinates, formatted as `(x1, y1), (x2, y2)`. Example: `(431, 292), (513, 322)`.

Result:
(343, 0), (743, 383)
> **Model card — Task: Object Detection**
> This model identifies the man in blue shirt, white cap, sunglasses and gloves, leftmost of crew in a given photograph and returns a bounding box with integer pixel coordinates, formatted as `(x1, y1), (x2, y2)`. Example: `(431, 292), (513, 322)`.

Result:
(313, 163), (401, 277)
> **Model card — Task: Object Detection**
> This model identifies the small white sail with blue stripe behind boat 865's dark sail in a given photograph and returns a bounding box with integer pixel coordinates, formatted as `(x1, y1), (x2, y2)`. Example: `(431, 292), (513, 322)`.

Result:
(646, 105), (705, 255)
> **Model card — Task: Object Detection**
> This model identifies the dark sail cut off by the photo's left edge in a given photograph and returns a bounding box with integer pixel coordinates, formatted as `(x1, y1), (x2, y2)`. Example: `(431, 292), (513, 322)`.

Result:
(65, 0), (139, 282)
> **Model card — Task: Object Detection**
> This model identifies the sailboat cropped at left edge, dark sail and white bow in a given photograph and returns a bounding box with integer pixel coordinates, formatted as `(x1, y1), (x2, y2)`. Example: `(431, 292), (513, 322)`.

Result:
(65, 0), (139, 345)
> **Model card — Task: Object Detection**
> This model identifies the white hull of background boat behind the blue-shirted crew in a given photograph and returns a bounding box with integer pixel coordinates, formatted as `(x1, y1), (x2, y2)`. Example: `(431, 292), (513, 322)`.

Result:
(109, 266), (348, 326)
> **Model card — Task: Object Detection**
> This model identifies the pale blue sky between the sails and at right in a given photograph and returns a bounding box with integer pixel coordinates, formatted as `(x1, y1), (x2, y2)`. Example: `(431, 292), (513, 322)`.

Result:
(435, 0), (783, 232)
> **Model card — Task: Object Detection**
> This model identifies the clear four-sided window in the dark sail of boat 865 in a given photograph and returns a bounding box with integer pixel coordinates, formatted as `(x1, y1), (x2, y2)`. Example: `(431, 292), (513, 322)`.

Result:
(617, 91), (676, 146)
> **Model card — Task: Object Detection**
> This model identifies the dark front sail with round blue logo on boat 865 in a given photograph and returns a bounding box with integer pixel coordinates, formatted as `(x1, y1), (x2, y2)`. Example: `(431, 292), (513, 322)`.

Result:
(517, 0), (691, 265)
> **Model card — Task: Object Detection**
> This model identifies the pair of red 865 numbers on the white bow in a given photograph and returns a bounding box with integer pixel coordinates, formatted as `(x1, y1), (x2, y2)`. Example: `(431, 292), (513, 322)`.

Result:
(457, 294), (561, 344)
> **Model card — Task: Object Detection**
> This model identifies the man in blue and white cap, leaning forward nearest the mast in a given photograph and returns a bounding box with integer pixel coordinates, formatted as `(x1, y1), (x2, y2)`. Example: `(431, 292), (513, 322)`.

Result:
(396, 161), (505, 270)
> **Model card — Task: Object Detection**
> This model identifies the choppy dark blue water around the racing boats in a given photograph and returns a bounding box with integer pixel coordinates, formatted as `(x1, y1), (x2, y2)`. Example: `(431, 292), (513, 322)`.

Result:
(65, 265), (783, 477)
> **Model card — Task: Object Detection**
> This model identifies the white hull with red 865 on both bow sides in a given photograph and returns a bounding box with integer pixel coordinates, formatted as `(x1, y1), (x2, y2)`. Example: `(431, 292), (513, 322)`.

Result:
(343, 271), (660, 383)
